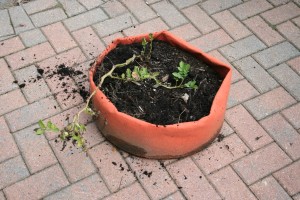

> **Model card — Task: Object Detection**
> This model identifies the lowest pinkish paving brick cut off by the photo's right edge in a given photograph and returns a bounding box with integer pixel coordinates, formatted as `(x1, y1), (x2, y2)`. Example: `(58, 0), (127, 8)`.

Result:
(274, 160), (300, 195)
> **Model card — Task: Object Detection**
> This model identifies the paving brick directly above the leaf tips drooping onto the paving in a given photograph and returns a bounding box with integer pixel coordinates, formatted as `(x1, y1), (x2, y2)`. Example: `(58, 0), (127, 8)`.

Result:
(6, 96), (60, 132)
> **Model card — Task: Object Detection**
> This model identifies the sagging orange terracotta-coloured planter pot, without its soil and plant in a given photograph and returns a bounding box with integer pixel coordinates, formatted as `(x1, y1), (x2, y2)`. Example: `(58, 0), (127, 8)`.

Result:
(89, 31), (232, 159)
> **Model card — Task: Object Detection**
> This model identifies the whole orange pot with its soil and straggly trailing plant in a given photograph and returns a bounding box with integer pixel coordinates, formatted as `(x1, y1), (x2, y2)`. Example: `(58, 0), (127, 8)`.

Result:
(36, 31), (231, 159)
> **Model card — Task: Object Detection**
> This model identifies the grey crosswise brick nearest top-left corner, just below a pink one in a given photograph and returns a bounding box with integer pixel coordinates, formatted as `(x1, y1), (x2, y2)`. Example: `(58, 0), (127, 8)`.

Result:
(30, 8), (67, 27)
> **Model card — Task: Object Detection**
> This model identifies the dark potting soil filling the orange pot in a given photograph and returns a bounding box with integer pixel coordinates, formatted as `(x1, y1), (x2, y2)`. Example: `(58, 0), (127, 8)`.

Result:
(94, 40), (223, 125)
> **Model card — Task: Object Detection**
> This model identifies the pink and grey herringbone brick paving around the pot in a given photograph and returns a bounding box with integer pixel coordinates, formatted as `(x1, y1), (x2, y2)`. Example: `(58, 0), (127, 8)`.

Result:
(0, 0), (300, 200)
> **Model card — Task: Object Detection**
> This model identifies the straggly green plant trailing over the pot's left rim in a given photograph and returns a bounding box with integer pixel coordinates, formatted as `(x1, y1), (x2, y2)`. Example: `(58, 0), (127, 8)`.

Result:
(35, 34), (198, 151)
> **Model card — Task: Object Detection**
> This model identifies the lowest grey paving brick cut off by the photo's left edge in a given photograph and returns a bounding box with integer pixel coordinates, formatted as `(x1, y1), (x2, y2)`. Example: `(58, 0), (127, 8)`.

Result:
(0, 156), (29, 189)
